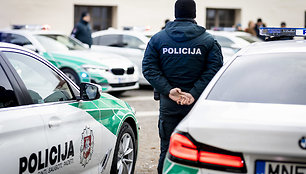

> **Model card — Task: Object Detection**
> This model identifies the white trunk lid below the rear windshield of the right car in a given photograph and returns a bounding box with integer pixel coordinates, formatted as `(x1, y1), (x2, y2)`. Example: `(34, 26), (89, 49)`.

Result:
(177, 100), (306, 156)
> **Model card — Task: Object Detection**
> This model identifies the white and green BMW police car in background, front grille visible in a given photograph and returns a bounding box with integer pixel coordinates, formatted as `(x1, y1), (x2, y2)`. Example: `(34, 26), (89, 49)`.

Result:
(0, 30), (139, 92)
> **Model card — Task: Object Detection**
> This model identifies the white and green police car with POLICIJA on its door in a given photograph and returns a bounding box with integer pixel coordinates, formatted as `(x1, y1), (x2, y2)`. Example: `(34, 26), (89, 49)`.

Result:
(0, 43), (138, 174)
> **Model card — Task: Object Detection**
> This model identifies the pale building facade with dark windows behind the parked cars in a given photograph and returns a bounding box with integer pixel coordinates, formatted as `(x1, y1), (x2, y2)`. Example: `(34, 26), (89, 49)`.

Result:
(0, 0), (306, 34)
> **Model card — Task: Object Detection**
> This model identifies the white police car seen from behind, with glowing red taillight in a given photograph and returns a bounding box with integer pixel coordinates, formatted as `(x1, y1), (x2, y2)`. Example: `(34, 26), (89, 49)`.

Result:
(163, 29), (306, 174)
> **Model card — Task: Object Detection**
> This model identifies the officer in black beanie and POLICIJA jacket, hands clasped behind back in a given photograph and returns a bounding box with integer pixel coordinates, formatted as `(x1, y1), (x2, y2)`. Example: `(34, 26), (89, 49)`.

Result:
(142, 0), (223, 173)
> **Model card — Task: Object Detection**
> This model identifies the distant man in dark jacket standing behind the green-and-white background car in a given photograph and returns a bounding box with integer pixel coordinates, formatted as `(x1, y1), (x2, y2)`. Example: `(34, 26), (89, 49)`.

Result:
(71, 12), (92, 48)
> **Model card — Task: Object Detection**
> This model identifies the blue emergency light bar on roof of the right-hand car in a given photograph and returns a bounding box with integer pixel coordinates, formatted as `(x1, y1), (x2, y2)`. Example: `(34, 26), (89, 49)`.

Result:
(260, 28), (306, 37)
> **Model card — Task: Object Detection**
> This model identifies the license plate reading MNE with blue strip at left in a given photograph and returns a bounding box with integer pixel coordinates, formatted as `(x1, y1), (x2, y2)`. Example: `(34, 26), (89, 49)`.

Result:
(255, 160), (306, 174)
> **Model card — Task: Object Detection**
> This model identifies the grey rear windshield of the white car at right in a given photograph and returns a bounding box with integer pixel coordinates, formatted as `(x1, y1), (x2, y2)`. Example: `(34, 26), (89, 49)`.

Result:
(207, 53), (306, 105)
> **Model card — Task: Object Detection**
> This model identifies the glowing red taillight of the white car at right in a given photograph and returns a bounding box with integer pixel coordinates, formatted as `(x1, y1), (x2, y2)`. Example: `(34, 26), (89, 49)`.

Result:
(169, 133), (246, 173)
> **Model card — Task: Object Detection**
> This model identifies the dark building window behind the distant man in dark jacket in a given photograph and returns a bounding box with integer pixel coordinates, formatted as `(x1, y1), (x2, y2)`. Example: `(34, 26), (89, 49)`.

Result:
(74, 5), (114, 31)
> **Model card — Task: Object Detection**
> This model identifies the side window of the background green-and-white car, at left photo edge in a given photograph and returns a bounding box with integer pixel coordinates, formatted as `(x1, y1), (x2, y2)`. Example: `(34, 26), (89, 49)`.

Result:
(0, 33), (32, 46)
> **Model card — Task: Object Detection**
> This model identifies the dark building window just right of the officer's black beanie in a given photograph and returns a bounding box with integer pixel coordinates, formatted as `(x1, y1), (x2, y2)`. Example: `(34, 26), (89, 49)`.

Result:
(206, 8), (240, 29)
